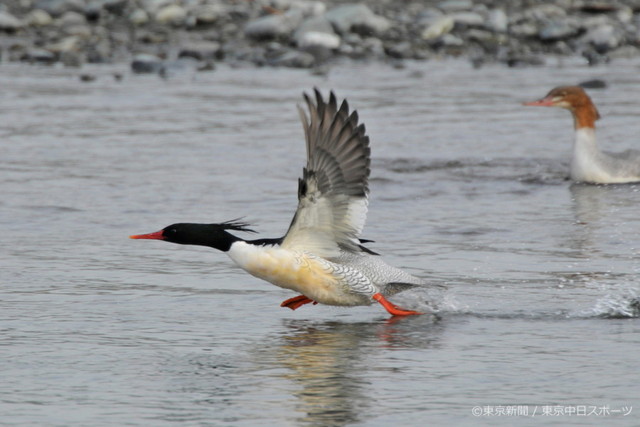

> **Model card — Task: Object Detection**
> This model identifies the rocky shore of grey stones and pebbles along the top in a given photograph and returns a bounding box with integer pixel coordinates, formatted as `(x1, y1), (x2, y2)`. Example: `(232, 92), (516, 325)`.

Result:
(0, 0), (640, 73)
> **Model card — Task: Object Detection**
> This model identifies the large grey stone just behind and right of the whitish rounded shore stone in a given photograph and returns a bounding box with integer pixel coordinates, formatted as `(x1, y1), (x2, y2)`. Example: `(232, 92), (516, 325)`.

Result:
(325, 4), (391, 35)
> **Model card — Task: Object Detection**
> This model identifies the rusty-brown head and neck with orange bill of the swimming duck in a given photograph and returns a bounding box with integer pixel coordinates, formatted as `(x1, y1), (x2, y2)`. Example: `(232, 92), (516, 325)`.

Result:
(524, 86), (600, 129)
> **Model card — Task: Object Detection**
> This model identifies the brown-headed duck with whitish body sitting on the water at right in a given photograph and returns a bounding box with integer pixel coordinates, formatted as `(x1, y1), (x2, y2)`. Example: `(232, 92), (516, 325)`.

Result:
(523, 86), (640, 184)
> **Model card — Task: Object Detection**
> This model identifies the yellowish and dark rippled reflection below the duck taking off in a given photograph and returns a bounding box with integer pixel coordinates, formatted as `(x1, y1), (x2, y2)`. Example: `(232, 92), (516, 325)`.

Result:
(256, 316), (442, 426)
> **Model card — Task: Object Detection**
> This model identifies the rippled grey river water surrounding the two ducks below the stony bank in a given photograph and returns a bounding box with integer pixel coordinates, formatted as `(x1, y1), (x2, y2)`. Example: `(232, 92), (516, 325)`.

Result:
(0, 60), (640, 426)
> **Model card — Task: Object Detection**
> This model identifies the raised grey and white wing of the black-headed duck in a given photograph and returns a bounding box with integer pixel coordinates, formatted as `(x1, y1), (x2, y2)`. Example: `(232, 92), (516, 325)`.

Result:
(282, 89), (371, 258)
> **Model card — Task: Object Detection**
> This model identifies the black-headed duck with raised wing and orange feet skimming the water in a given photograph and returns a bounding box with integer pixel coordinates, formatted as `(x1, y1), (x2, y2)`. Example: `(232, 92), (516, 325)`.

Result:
(129, 88), (426, 316)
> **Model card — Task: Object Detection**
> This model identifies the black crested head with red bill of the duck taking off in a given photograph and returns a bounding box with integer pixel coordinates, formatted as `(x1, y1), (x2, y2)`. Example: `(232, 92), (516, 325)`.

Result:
(130, 220), (255, 252)
